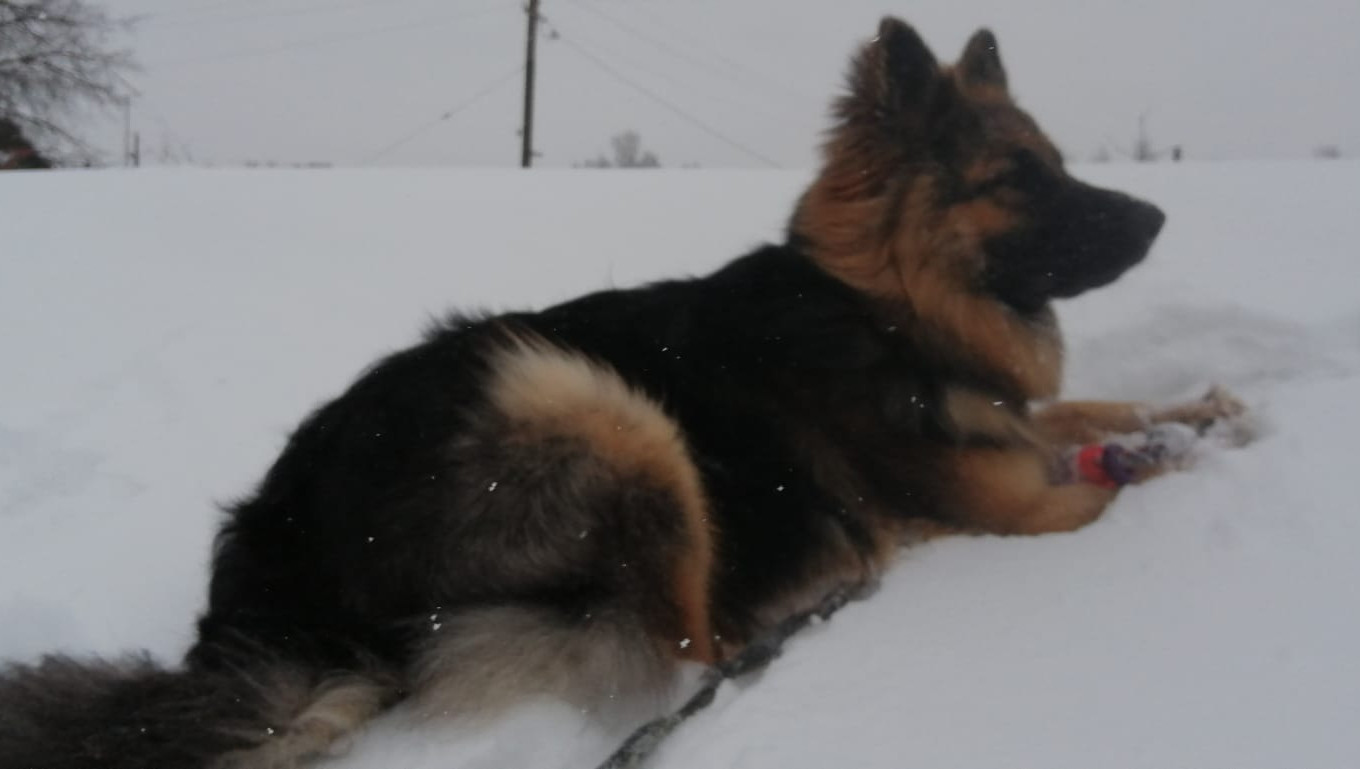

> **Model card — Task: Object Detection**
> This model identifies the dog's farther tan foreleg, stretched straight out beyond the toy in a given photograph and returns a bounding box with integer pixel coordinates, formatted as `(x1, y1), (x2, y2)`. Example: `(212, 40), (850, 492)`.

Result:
(1031, 388), (1244, 445)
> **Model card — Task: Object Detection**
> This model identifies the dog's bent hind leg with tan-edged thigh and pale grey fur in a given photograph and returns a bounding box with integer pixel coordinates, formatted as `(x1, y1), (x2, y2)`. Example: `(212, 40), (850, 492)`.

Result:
(411, 340), (717, 715)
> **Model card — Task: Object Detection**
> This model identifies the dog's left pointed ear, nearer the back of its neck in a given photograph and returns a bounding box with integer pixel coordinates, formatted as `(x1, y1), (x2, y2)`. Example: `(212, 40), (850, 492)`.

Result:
(850, 16), (940, 116)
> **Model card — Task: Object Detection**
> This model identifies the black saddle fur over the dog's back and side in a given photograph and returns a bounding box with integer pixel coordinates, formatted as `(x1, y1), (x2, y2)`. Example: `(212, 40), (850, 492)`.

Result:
(193, 246), (946, 664)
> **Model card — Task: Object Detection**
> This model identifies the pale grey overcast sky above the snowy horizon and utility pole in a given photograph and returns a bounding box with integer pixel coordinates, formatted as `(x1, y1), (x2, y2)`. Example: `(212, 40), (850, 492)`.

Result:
(97, 0), (1360, 167)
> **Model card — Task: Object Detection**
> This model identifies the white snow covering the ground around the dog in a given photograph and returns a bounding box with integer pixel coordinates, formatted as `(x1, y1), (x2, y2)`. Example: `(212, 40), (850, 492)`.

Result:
(0, 162), (1360, 769)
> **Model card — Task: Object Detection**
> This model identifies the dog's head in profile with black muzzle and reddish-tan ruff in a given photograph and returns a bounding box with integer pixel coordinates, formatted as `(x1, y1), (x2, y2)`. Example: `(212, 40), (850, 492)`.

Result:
(790, 18), (1164, 317)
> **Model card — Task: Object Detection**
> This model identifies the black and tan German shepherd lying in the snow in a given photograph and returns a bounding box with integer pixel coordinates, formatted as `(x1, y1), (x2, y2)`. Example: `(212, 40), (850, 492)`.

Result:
(0, 18), (1236, 769)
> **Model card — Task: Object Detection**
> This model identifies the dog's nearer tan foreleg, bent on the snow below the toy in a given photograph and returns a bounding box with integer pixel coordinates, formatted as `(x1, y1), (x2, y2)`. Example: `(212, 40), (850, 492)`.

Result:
(949, 449), (1117, 535)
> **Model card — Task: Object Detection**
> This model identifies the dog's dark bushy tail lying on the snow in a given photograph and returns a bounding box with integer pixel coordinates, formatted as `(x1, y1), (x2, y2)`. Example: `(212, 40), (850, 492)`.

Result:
(0, 647), (384, 769)
